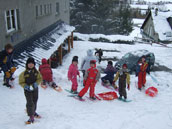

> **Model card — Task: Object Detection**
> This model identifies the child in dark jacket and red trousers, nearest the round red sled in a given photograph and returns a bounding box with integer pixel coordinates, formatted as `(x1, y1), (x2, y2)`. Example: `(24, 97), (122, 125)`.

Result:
(136, 56), (148, 90)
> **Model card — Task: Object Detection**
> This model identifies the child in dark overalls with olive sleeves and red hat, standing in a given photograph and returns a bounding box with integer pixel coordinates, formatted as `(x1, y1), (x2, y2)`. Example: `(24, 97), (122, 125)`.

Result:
(113, 64), (130, 100)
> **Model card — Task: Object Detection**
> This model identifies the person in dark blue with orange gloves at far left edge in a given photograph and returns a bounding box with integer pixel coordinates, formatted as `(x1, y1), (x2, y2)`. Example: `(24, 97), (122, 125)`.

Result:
(0, 44), (16, 88)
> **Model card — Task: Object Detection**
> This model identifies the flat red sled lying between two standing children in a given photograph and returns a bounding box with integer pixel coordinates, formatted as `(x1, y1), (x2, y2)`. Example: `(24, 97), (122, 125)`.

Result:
(98, 92), (118, 100)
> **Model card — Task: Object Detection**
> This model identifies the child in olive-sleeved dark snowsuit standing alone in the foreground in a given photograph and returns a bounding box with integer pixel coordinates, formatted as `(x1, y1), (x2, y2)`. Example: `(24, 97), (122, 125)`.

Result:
(19, 57), (42, 124)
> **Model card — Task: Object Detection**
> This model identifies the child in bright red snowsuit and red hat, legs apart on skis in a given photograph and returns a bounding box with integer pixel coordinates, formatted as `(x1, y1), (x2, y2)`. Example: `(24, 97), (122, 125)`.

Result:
(78, 60), (100, 100)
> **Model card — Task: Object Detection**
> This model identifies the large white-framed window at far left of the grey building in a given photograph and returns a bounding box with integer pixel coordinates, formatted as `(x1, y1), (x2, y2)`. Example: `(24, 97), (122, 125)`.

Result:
(5, 9), (19, 33)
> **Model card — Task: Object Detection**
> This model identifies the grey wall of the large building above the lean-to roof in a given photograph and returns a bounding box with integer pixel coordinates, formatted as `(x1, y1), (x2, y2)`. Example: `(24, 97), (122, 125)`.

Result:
(0, 0), (70, 50)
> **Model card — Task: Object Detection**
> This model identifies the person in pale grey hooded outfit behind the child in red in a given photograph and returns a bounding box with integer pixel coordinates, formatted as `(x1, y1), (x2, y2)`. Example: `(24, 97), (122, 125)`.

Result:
(81, 49), (97, 77)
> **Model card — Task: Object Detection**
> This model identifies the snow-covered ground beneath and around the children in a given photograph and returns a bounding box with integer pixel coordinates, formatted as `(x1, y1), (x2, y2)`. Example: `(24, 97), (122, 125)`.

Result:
(0, 37), (172, 129)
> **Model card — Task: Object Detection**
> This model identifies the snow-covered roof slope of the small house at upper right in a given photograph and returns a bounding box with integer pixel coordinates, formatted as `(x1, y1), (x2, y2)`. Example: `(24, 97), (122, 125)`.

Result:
(151, 10), (172, 41)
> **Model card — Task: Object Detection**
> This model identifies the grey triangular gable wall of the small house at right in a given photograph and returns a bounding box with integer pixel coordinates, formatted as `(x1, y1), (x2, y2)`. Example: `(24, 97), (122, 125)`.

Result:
(143, 17), (159, 41)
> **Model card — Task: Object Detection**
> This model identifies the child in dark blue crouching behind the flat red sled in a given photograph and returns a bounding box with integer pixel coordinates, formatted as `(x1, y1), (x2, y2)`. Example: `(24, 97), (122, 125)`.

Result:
(101, 61), (116, 85)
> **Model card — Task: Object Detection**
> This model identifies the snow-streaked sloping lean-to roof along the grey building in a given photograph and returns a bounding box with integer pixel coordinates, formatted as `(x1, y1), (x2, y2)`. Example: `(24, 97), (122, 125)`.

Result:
(16, 22), (75, 65)
